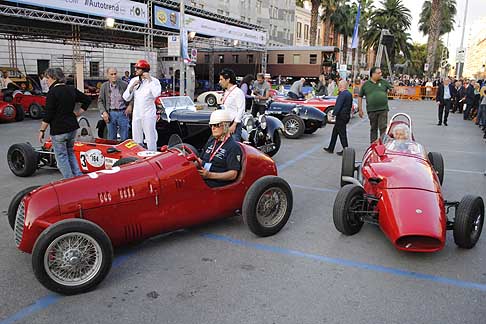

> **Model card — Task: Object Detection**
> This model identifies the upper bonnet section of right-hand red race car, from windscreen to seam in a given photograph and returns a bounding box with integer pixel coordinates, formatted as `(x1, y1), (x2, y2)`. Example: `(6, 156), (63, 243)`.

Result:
(363, 155), (440, 192)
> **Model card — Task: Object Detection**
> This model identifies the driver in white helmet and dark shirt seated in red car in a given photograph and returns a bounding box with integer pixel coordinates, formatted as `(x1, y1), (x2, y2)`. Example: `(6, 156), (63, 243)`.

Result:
(199, 110), (242, 187)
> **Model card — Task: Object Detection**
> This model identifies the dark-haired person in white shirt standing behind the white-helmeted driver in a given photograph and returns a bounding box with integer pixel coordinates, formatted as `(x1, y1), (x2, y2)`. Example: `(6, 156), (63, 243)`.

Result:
(219, 69), (245, 142)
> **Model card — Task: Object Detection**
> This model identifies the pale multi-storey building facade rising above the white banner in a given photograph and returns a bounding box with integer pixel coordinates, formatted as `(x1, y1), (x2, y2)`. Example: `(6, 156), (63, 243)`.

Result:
(186, 0), (296, 46)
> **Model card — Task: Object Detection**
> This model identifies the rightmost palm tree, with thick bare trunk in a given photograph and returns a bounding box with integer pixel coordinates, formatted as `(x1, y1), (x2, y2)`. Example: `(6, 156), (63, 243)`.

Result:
(419, 0), (457, 76)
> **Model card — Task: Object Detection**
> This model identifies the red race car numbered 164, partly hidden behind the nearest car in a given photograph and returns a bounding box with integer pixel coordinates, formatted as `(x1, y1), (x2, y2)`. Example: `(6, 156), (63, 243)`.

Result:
(7, 117), (148, 177)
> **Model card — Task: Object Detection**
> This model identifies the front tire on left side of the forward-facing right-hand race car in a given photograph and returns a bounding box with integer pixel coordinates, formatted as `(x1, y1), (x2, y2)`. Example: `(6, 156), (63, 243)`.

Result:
(332, 184), (364, 235)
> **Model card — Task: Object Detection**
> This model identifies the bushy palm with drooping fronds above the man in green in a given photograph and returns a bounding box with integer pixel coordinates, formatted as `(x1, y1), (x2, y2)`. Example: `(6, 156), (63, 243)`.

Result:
(363, 0), (412, 73)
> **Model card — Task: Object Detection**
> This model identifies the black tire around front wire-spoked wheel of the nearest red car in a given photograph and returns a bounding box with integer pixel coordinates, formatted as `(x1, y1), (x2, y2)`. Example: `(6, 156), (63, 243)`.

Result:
(32, 218), (113, 295)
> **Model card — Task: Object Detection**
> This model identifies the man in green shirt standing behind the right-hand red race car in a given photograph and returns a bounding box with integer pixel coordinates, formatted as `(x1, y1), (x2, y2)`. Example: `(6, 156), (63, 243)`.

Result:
(358, 66), (393, 143)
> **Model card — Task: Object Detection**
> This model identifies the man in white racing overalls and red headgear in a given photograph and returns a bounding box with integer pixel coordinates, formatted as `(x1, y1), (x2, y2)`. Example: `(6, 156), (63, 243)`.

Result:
(123, 60), (161, 151)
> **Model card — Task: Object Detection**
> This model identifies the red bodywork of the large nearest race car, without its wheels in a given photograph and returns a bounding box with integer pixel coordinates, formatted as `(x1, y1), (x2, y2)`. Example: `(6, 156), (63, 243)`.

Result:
(17, 144), (277, 253)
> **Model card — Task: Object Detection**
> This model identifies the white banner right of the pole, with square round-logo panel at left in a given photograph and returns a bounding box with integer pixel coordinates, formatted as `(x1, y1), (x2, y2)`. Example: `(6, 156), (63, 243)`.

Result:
(154, 6), (267, 45)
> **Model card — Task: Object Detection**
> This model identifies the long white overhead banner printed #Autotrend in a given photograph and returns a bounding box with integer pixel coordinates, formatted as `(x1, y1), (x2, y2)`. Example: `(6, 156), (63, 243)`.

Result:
(7, 0), (148, 24)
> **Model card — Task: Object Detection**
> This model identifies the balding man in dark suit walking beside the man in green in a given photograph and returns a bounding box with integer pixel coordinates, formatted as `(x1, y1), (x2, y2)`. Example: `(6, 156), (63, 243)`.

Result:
(323, 80), (353, 155)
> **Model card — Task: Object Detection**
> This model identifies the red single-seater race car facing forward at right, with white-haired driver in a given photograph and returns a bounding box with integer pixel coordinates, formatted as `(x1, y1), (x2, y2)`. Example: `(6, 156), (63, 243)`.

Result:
(333, 114), (484, 252)
